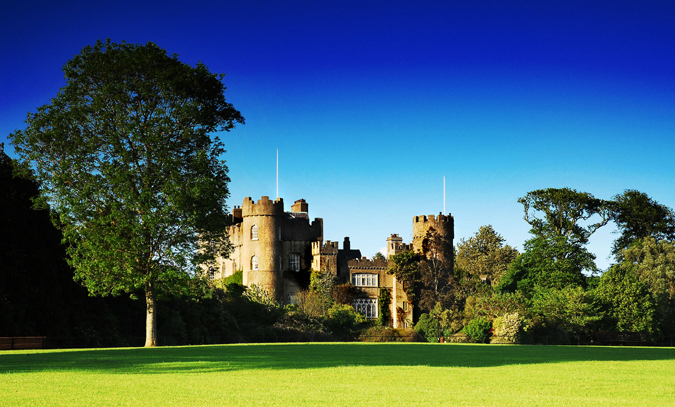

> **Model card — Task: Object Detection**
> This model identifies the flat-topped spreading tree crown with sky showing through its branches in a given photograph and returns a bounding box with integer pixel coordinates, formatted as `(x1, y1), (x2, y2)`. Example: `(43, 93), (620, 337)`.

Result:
(518, 188), (610, 245)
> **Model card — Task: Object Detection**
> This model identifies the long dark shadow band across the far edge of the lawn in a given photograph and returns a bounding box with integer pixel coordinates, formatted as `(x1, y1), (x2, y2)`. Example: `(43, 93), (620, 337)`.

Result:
(0, 343), (675, 374)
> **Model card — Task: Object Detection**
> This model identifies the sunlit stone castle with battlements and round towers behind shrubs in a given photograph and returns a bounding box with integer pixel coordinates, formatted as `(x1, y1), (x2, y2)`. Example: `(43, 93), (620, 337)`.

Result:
(217, 196), (454, 328)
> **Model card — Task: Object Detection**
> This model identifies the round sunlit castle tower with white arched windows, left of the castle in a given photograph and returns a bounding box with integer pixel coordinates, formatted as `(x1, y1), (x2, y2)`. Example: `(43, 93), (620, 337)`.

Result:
(241, 196), (284, 297)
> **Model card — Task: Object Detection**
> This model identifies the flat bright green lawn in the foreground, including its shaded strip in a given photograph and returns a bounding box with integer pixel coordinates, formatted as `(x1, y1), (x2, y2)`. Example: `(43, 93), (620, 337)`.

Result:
(0, 343), (675, 407)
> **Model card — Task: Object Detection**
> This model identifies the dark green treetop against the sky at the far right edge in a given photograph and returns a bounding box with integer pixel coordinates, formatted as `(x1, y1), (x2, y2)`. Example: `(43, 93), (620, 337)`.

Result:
(609, 189), (675, 260)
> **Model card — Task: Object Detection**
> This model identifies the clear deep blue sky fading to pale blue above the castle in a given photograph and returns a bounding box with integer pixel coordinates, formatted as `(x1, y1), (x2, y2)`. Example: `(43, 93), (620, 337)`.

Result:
(0, 1), (675, 268)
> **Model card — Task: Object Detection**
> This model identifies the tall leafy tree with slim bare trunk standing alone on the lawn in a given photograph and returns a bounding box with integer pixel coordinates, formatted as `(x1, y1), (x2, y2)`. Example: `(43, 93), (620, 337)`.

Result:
(10, 40), (244, 346)
